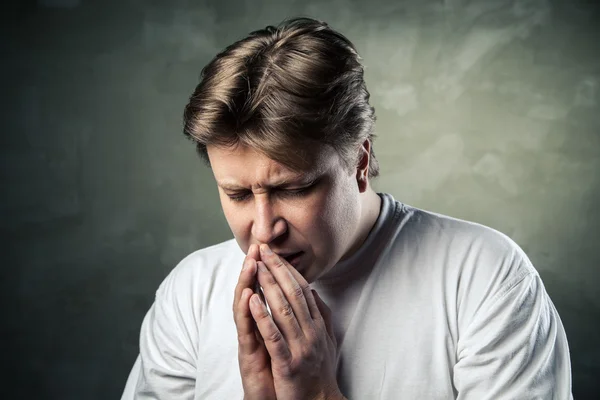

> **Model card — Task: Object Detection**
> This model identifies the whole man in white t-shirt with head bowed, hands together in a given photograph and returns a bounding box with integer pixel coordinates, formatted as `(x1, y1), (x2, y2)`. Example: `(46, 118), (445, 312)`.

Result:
(123, 18), (572, 400)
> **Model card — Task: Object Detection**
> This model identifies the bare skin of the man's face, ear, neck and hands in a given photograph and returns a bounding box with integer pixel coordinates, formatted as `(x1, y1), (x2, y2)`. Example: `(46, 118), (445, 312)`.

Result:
(208, 141), (380, 400)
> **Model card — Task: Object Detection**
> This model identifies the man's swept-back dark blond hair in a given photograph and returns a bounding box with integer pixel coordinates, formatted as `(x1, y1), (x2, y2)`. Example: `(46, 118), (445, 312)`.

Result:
(184, 17), (379, 178)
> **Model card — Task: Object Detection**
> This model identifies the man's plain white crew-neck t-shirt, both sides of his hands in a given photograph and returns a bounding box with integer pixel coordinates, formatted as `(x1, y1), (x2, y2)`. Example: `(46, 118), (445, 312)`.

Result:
(122, 193), (572, 400)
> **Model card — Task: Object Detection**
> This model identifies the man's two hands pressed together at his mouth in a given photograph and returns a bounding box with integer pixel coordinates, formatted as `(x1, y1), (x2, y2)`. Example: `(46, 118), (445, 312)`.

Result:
(233, 245), (344, 400)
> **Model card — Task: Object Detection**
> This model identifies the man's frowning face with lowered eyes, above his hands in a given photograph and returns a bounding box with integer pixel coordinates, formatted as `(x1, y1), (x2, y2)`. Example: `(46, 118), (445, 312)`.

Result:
(208, 145), (361, 282)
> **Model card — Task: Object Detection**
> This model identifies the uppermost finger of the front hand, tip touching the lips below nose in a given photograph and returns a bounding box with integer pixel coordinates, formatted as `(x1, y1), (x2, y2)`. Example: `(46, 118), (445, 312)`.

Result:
(260, 245), (314, 332)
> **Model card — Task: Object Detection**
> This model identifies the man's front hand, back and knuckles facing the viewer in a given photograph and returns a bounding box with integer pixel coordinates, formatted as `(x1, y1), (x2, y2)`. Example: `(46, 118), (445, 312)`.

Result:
(250, 245), (343, 400)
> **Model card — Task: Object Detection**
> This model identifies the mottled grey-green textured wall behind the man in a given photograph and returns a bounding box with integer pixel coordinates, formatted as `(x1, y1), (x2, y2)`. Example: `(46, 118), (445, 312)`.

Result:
(0, 0), (600, 399)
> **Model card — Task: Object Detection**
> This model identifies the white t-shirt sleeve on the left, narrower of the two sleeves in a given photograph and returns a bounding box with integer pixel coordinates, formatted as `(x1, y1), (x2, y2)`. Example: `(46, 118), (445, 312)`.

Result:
(122, 285), (196, 400)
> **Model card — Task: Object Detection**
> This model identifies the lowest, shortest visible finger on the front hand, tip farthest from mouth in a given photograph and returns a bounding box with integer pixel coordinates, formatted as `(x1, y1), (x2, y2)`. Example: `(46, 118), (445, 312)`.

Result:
(250, 294), (292, 362)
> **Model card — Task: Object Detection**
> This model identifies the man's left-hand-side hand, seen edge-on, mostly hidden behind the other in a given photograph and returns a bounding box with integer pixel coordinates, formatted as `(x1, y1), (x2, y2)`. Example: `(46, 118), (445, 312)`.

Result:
(233, 245), (277, 400)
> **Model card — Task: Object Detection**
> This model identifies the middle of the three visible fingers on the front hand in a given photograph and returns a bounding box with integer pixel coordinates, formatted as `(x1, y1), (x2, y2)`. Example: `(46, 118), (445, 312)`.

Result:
(257, 261), (304, 342)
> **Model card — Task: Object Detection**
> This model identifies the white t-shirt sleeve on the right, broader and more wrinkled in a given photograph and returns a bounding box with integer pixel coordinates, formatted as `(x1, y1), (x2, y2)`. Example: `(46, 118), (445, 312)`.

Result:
(453, 268), (573, 400)
